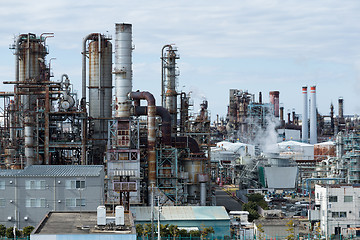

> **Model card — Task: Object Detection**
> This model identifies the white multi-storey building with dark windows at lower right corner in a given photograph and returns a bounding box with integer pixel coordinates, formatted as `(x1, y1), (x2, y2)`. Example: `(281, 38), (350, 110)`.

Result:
(310, 184), (360, 236)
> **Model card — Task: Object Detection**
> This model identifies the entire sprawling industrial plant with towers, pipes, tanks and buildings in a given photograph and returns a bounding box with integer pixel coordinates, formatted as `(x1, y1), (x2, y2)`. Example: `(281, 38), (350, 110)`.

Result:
(0, 23), (360, 239)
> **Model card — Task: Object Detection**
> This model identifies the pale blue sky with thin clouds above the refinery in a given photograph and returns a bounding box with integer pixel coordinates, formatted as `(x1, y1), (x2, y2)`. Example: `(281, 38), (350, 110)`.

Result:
(0, 0), (360, 120)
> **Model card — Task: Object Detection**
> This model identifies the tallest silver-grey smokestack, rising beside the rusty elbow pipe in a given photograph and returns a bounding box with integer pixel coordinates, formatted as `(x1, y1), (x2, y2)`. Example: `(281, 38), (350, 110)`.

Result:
(114, 23), (132, 118)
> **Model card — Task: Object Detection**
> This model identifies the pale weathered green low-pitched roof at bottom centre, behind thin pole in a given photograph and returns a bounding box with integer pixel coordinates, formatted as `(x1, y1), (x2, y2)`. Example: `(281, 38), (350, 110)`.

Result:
(131, 206), (230, 221)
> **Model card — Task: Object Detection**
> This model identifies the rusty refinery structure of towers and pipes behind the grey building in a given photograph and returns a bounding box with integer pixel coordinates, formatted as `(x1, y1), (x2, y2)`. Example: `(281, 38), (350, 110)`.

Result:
(0, 23), (211, 209)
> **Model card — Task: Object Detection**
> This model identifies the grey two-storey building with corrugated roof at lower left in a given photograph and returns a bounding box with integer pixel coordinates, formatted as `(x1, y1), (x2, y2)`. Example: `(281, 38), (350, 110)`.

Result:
(0, 165), (104, 228)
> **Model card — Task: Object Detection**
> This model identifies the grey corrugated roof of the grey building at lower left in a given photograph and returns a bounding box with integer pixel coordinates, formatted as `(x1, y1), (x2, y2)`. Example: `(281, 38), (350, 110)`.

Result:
(0, 165), (104, 177)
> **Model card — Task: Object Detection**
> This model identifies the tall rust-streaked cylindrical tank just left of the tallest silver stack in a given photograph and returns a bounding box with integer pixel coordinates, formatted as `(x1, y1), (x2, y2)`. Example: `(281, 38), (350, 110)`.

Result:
(89, 34), (112, 139)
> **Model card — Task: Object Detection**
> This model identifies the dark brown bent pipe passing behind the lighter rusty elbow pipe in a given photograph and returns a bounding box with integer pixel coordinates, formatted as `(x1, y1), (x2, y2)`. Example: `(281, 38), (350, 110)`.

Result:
(135, 106), (171, 145)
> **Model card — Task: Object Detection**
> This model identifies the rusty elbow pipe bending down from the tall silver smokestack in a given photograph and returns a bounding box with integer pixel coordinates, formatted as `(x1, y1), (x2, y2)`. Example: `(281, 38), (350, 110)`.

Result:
(129, 92), (156, 187)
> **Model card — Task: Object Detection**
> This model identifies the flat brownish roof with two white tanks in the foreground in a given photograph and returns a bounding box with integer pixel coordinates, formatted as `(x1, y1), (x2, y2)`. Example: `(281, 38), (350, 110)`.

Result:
(33, 211), (136, 235)
